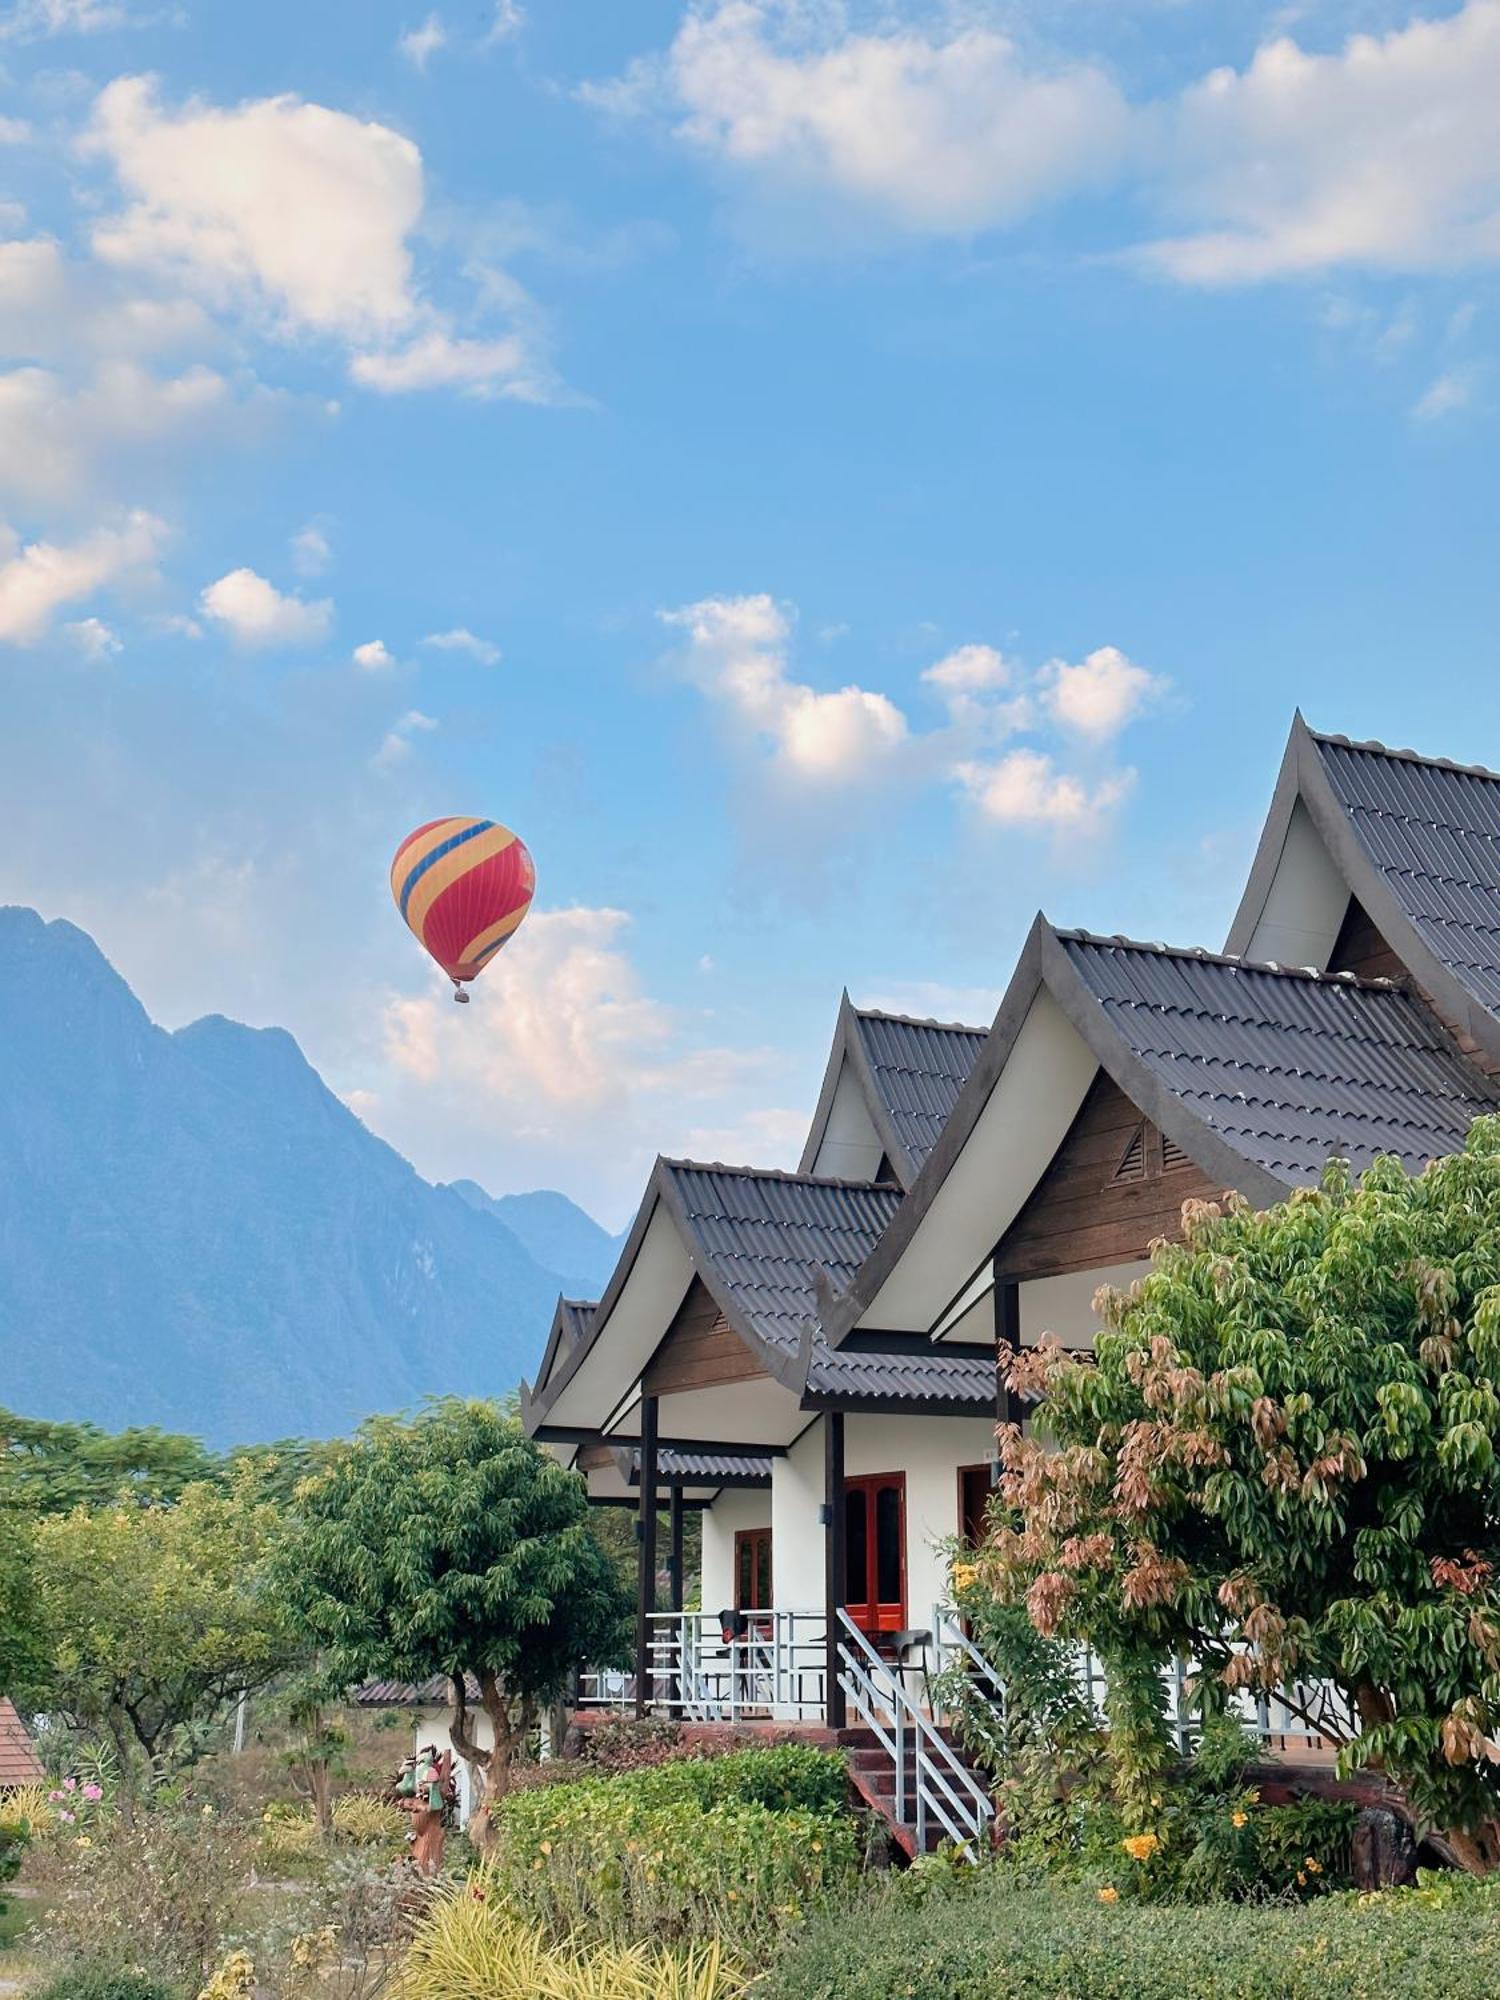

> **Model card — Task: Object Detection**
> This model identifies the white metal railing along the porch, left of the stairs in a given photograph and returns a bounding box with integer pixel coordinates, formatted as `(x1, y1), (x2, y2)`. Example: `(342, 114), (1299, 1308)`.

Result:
(578, 1610), (828, 1722)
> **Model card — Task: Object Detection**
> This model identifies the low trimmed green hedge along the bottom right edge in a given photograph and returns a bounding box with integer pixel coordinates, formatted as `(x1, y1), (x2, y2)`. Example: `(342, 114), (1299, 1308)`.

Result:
(752, 1870), (1500, 2000)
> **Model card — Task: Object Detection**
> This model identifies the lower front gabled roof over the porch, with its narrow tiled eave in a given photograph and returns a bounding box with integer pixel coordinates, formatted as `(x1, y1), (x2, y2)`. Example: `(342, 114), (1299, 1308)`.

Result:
(522, 1160), (994, 1432)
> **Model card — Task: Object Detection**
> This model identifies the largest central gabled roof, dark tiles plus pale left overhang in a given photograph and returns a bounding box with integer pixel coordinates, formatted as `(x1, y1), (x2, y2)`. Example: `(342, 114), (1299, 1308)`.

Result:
(822, 916), (1500, 1352)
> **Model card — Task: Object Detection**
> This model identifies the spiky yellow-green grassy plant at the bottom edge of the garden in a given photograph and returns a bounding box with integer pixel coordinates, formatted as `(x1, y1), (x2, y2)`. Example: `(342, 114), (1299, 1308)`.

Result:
(390, 1886), (744, 2000)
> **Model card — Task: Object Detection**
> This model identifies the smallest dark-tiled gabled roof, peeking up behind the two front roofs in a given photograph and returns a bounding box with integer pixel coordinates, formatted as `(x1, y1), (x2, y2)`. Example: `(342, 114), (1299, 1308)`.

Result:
(798, 994), (986, 1188)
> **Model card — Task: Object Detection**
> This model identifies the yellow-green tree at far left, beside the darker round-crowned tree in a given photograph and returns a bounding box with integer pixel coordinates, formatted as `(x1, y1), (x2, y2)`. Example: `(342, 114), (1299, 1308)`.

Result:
(28, 1486), (298, 1774)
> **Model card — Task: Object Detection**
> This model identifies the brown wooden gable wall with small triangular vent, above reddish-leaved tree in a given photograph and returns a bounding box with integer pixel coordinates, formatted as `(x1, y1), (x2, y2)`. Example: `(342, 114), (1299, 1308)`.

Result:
(996, 1070), (1224, 1280)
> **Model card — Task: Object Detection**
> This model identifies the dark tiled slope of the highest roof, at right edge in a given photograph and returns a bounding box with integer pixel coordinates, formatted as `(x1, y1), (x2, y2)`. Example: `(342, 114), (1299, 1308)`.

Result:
(1310, 732), (1500, 1014)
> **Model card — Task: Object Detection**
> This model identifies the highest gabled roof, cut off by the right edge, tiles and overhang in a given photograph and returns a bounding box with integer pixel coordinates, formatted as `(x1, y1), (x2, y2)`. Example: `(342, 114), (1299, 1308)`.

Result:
(1228, 716), (1500, 1060)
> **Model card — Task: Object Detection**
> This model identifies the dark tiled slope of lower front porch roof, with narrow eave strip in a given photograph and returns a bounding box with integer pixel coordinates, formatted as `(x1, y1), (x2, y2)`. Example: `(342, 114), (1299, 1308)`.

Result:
(662, 1160), (994, 1408)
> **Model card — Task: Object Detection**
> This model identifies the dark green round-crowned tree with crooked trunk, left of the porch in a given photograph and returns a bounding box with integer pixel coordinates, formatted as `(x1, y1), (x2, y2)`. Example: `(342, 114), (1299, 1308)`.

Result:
(278, 1398), (630, 1796)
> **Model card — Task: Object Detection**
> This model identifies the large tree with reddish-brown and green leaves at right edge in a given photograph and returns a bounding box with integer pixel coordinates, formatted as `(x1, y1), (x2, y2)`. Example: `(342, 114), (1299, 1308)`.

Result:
(980, 1118), (1500, 1874)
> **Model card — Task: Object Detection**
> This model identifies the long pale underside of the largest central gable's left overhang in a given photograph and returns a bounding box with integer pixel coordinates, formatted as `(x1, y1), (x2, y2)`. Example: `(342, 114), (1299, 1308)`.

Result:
(858, 986), (1098, 1334)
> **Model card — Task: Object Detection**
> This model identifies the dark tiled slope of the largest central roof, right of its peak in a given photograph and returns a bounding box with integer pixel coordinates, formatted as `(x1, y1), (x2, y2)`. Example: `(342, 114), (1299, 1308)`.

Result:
(1058, 932), (1500, 1186)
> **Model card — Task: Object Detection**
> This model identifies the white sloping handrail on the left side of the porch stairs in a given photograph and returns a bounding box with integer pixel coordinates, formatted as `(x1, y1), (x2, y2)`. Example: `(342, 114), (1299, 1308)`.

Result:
(838, 1610), (994, 1862)
